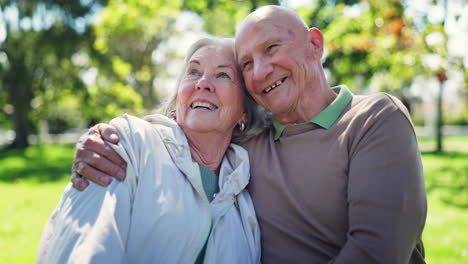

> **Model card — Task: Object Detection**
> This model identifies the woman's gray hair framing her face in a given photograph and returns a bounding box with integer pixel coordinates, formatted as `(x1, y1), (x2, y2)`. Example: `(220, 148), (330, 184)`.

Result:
(157, 36), (271, 143)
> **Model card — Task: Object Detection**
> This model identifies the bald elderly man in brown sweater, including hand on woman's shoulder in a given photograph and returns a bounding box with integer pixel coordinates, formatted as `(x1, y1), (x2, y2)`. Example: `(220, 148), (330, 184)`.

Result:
(73, 6), (427, 264)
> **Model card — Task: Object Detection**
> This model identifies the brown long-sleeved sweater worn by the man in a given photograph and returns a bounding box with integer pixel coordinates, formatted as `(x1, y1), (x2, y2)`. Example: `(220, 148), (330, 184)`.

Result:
(243, 93), (427, 264)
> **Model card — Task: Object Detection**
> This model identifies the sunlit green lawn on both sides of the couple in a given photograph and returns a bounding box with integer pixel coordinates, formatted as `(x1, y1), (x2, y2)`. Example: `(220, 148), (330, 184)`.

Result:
(0, 140), (468, 264)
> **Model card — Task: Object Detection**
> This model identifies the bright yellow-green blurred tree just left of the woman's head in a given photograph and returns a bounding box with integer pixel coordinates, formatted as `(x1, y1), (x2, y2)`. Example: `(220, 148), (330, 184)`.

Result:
(87, 0), (182, 111)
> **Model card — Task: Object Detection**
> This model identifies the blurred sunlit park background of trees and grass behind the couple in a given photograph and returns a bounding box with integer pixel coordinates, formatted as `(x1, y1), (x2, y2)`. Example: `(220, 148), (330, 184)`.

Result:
(0, 0), (468, 264)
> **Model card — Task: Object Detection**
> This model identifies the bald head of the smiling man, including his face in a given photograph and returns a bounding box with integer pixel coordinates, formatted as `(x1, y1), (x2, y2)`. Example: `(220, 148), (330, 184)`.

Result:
(236, 6), (326, 120)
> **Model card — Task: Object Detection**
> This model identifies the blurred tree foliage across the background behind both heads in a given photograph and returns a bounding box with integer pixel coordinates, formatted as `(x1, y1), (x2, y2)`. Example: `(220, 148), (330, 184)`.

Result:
(0, 0), (468, 151)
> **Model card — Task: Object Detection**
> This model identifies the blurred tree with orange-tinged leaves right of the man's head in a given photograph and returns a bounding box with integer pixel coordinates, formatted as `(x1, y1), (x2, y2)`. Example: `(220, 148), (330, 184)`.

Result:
(312, 0), (424, 111)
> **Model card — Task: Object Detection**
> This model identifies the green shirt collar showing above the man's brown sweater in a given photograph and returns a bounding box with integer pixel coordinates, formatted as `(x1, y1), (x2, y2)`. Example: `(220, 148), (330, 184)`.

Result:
(273, 85), (353, 140)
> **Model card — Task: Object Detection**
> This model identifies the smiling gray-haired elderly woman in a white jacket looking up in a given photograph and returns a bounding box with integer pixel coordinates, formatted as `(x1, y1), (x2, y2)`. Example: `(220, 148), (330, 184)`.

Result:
(38, 38), (266, 263)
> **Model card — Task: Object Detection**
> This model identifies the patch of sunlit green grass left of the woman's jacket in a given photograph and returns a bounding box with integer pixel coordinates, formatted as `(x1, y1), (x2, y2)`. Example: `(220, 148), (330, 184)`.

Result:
(0, 145), (74, 263)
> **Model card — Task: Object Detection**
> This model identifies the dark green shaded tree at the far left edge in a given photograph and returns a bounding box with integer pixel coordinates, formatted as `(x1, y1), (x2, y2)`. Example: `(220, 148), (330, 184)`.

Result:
(0, 0), (106, 148)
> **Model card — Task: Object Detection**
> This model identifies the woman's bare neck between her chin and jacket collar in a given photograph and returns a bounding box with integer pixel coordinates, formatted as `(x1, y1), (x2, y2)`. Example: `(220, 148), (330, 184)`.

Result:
(184, 131), (231, 174)
